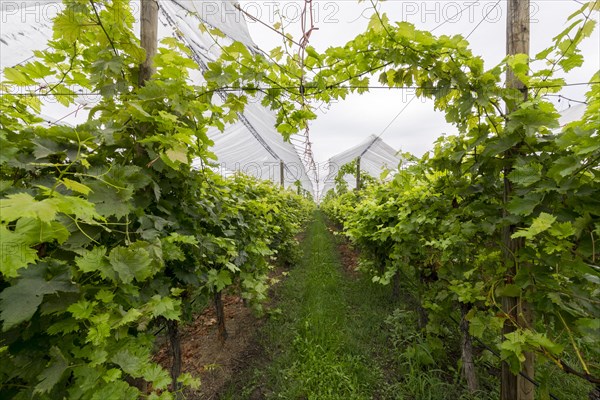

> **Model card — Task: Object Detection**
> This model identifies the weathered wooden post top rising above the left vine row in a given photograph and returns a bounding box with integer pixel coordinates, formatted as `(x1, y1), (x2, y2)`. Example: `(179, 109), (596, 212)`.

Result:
(139, 0), (158, 86)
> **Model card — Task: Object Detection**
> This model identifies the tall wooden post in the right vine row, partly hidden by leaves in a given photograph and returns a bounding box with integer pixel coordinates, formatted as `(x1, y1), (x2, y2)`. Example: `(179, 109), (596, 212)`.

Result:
(500, 0), (534, 400)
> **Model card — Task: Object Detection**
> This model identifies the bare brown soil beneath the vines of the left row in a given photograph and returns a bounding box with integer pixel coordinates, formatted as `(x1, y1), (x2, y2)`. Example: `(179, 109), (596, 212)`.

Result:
(155, 295), (263, 400)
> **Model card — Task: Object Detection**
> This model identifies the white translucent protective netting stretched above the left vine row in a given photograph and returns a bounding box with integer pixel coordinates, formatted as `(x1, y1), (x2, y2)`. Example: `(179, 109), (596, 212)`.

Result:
(0, 0), (314, 194)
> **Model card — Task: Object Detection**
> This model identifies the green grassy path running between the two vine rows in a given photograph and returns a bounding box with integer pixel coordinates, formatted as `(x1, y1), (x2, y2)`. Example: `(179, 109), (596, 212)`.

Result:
(219, 212), (590, 400)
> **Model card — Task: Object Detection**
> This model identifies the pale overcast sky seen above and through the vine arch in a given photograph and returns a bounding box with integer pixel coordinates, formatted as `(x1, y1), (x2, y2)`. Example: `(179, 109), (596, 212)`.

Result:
(240, 0), (600, 162)
